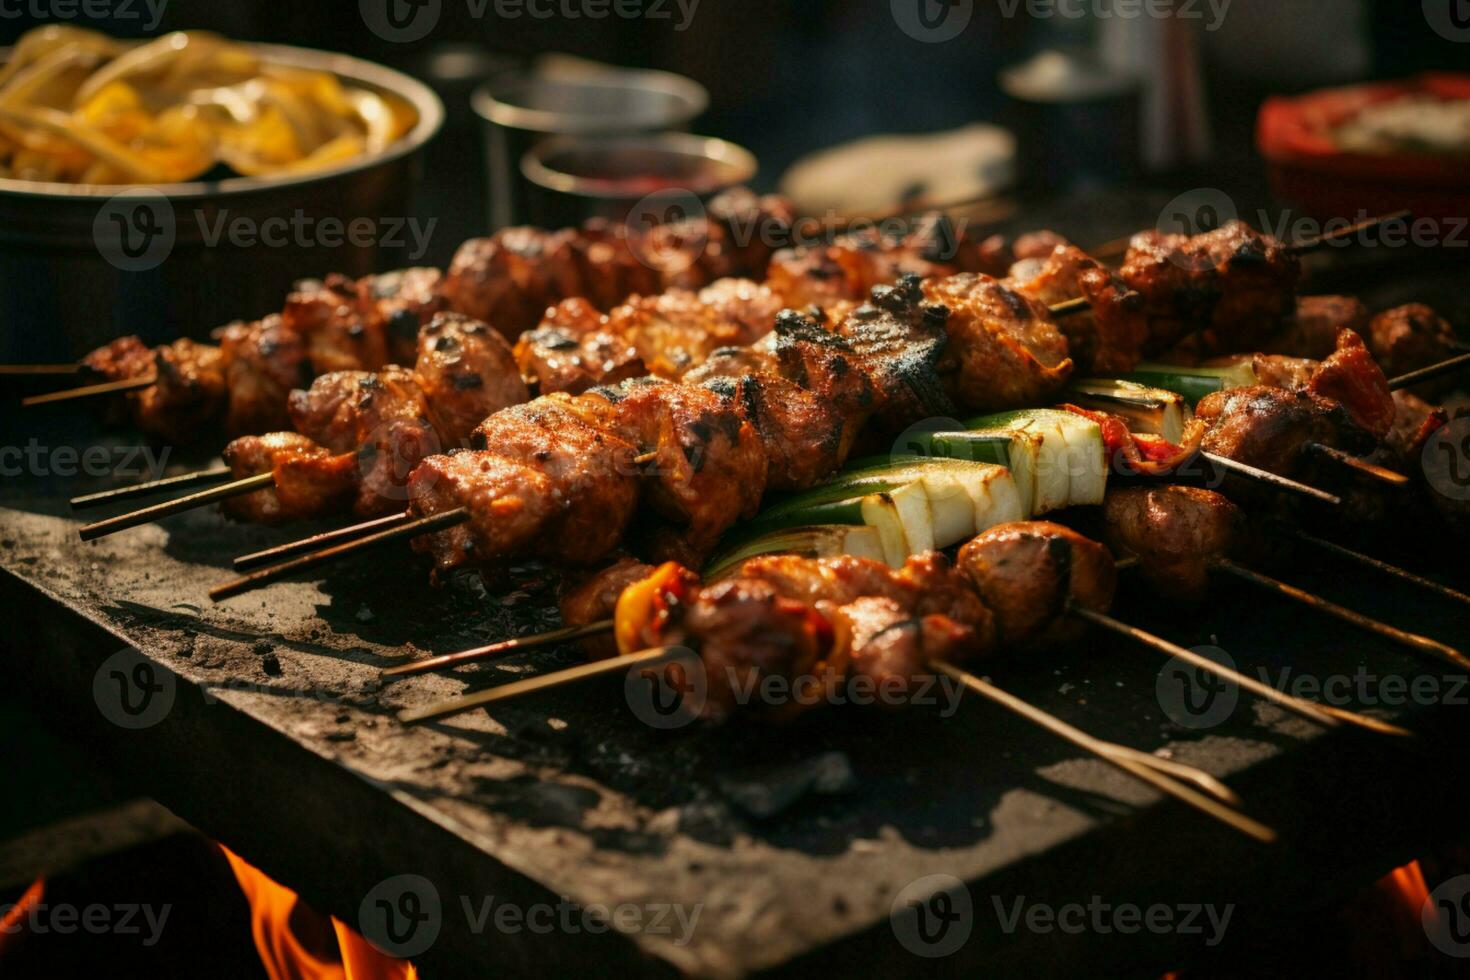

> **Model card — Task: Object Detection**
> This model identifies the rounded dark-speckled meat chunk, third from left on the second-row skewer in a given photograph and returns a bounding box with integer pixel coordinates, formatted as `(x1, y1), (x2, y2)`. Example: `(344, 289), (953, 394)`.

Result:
(415, 313), (531, 447)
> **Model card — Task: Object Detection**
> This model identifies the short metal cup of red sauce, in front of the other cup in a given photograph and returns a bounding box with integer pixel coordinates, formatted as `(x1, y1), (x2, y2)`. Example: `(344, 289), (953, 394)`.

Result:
(520, 132), (757, 228)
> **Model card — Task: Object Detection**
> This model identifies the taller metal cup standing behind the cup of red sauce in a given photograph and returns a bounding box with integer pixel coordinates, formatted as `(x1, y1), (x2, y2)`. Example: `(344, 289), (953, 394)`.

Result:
(472, 68), (709, 231)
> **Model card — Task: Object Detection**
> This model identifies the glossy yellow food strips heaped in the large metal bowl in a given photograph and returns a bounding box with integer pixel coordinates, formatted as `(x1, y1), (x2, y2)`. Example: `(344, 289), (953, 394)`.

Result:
(0, 25), (417, 184)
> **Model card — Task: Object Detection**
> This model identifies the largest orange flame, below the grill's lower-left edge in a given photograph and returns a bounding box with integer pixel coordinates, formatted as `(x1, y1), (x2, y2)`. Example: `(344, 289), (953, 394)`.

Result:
(219, 845), (419, 980)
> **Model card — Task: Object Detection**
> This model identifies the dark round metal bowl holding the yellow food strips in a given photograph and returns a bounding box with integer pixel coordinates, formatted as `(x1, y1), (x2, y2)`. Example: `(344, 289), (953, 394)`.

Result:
(0, 44), (444, 361)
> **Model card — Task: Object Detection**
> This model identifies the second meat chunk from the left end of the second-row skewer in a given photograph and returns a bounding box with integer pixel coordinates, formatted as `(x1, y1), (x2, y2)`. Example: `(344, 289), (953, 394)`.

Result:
(291, 364), (442, 517)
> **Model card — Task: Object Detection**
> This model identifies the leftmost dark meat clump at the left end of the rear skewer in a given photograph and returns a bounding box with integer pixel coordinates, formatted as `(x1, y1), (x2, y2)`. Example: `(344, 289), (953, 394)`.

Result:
(82, 336), (228, 442)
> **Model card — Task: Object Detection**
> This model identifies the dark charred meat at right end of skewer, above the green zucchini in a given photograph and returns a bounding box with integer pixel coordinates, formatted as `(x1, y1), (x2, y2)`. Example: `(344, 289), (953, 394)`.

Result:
(1120, 220), (1301, 356)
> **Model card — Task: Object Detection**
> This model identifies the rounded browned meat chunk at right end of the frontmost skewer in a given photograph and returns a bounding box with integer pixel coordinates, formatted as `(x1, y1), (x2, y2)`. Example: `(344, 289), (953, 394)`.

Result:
(957, 520), (1117, 648)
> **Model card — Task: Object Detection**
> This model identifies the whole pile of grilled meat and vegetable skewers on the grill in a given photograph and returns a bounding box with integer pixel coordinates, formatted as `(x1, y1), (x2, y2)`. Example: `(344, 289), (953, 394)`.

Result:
(14, 195), (1470, 837)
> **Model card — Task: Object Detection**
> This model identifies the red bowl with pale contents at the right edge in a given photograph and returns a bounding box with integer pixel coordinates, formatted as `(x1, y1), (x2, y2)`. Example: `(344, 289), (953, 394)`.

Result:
(1255, 73), (1470, 220)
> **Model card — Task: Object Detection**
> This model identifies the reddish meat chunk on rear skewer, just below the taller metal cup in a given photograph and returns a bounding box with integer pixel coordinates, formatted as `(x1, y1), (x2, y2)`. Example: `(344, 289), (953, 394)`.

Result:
(442, 228), (584, 338)
